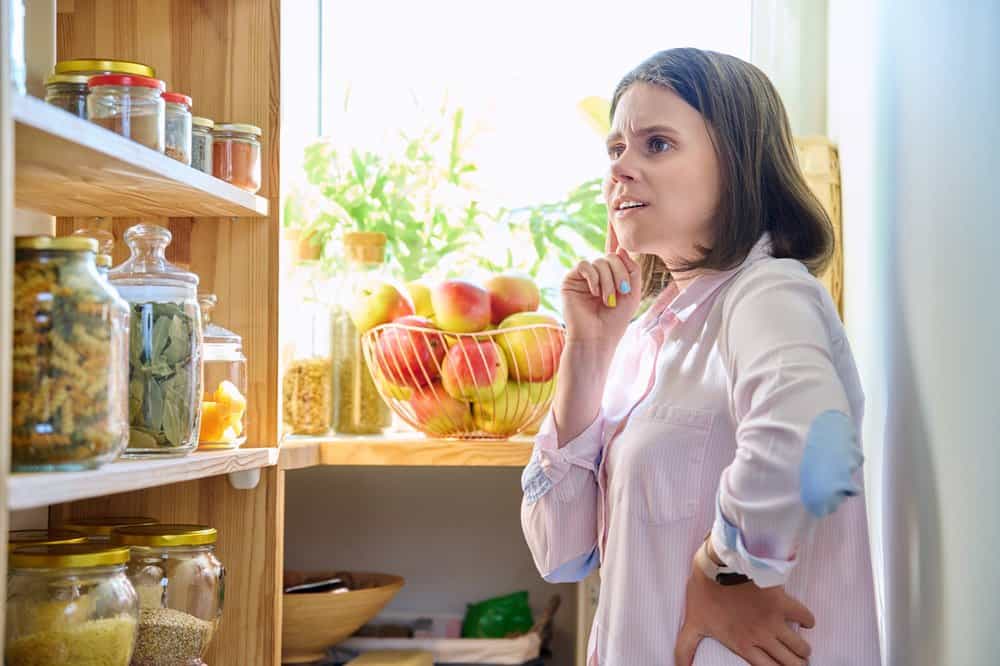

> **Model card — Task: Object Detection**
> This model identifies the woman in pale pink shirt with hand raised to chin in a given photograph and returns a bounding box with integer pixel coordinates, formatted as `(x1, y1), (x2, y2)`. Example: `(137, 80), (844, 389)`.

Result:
(522, 49), (879, 666)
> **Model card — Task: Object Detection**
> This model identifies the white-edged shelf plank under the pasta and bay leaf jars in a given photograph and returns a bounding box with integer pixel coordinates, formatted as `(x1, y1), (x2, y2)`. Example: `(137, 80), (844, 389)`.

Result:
(7, 447), (278, 511)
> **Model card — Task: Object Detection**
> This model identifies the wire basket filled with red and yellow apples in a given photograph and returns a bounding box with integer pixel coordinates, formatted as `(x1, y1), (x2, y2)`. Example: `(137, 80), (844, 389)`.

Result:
(362, 321), (566, 440)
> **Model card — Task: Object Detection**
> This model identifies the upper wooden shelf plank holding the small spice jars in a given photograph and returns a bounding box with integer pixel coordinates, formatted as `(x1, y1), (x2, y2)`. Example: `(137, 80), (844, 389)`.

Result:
(13, 95), (267, 217)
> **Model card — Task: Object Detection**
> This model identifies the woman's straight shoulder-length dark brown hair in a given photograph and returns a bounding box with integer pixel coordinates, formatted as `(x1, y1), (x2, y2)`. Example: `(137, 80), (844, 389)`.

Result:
(611, 48), (833, 296)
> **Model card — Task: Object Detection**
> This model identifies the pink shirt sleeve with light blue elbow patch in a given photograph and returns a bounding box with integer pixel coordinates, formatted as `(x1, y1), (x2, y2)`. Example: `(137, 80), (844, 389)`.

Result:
(711, 265), (863, 587)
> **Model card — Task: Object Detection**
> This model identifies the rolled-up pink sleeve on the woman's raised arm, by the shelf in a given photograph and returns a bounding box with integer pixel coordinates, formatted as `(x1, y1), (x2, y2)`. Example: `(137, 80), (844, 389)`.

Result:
(521, 412), (604, 583)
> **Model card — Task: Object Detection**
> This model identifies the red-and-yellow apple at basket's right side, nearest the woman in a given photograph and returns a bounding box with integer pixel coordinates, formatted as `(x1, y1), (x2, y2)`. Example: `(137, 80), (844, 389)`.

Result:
(497, 312), (565, 382)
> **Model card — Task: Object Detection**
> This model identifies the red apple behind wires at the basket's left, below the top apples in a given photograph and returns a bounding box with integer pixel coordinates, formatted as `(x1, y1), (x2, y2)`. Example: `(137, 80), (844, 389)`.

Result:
(375, 315), (445, 386)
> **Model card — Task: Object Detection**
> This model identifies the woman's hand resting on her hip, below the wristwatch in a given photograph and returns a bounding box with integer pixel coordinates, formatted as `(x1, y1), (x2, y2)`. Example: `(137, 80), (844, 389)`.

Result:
(674, 548), (816, 666)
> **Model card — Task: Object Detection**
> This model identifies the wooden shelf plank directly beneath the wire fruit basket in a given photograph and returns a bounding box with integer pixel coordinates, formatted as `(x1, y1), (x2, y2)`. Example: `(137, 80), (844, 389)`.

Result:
(279, 432), (533, 470)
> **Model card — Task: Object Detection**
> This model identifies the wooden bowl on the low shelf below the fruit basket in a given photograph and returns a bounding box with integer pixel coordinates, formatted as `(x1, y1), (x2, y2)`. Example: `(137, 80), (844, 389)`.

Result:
(281, 572), (406, 664)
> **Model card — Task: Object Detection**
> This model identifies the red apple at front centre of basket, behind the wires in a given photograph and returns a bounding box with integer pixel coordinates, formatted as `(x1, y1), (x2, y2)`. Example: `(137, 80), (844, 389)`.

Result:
(441, 338), (507, 402)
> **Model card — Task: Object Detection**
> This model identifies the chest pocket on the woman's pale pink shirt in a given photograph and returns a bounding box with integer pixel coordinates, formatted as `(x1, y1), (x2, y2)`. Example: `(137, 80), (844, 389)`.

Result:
(622, 405), (715, 525)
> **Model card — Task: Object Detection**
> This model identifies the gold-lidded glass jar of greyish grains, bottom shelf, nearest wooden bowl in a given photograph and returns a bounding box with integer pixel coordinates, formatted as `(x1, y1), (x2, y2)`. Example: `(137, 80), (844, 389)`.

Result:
(111, 525), (225, 666)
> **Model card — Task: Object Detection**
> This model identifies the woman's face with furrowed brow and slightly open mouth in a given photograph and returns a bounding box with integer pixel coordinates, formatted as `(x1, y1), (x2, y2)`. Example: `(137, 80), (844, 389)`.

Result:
(604, 83), (720, 267)
